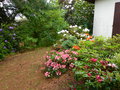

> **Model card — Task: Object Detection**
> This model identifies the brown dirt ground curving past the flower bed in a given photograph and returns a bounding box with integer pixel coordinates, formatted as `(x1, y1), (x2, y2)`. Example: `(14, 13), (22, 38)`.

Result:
(0, 48), (73, 90)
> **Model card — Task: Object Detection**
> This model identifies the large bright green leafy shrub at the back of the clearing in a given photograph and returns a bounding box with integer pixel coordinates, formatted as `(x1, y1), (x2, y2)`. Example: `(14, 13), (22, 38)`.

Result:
(15, 0), (68, 48)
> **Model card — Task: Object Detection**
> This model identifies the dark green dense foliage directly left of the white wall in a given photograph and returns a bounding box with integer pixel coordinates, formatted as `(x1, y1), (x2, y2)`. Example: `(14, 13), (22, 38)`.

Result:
(65, 0), (94, 32)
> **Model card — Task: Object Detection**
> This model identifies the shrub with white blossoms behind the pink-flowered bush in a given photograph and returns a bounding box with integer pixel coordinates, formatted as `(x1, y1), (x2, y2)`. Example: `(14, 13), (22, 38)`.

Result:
(55, 25), (93, 49)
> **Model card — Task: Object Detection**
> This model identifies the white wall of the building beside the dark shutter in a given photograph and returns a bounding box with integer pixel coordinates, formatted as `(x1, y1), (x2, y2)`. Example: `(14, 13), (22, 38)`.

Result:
(93, 0), (120, 37)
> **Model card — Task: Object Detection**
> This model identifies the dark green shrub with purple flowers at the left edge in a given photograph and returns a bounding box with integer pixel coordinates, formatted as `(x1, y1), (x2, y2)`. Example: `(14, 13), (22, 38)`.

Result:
(0, 24), (19, 59)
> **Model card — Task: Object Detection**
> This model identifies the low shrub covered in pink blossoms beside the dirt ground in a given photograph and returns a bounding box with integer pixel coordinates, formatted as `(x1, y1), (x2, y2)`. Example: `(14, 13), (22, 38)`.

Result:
(44, 50), (78, 77)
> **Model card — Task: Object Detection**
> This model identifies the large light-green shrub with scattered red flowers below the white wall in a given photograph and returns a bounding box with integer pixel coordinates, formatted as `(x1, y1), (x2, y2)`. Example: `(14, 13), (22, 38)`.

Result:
(72, 36), (120, 90)
